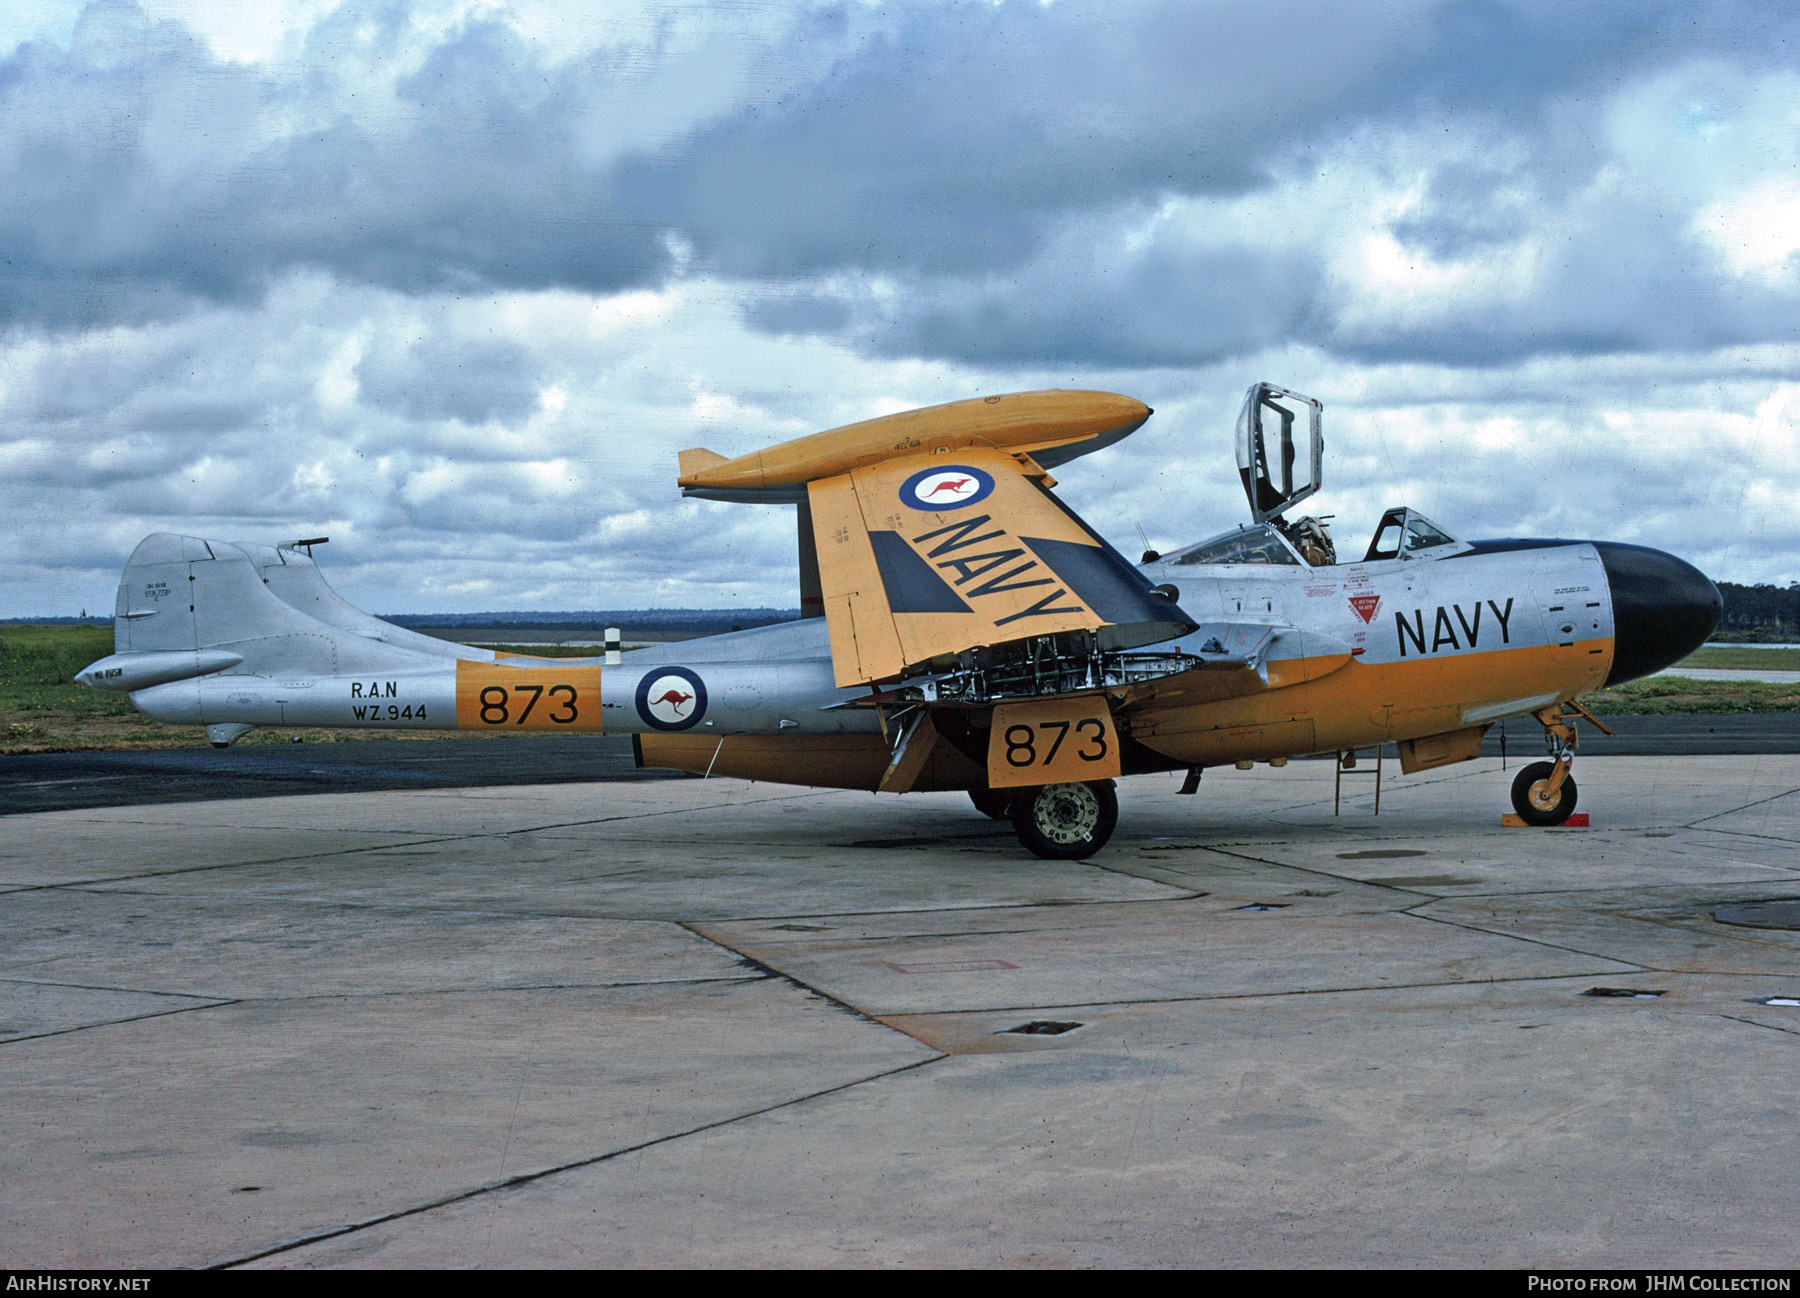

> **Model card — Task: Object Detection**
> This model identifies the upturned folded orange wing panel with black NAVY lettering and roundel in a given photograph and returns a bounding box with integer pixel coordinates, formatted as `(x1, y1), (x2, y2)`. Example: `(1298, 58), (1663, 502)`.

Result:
(808, 448), (1195, 686)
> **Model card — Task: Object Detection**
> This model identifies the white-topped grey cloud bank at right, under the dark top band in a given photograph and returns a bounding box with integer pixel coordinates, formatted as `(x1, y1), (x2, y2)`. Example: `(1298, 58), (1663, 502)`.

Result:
(766, 63), (1800, 365)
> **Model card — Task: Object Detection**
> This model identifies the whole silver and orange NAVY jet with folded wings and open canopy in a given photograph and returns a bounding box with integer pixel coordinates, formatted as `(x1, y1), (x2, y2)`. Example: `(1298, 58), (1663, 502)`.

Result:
(76, 383), (1721, 859)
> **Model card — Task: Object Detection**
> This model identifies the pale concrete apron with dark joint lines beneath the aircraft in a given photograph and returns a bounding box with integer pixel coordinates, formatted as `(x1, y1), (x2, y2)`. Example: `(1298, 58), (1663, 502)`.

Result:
(0, 745), (1800, 1267)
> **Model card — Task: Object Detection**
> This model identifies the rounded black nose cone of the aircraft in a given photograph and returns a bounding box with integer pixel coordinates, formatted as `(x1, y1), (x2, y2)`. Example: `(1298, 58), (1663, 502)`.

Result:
(1593, 540), (1724, 686)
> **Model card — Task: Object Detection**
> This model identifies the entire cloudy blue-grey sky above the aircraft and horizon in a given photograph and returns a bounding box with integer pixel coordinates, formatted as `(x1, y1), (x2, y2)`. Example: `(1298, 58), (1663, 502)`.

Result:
(0, 0), (1800, 617)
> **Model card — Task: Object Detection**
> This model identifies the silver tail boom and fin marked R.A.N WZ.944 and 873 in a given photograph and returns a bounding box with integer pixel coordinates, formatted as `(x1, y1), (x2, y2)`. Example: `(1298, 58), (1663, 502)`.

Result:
(76, 533), (880, 745)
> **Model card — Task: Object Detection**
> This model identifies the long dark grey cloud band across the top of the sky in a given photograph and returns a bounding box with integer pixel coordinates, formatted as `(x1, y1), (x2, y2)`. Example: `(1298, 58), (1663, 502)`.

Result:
(0, 0), (1793, 342)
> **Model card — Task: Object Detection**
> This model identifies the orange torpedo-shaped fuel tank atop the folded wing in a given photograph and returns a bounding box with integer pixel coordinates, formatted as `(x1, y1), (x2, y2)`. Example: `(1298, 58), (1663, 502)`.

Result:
(677, 389), (1150, 502)
